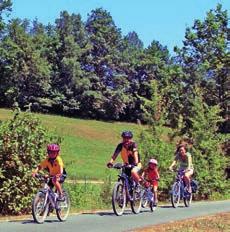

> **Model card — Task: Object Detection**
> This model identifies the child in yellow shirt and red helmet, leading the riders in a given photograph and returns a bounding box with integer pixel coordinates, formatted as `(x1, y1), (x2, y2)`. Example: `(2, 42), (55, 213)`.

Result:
(32, 144), (66, 201)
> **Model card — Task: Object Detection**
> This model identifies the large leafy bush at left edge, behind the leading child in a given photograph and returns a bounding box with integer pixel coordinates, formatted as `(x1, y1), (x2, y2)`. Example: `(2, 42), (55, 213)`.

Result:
(0, 109), (51, 214)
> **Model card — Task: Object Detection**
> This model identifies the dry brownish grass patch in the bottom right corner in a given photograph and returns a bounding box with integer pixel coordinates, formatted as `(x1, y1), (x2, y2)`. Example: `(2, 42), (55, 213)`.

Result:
(136, 212), (230, 232)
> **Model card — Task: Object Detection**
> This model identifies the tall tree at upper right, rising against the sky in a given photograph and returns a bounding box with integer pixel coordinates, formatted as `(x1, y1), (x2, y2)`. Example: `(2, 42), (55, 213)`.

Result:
(176, 4), (230, 132)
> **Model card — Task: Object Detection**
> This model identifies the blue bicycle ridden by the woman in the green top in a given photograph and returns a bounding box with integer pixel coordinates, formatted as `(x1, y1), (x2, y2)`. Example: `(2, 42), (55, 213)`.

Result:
(170, 170), (192, 208)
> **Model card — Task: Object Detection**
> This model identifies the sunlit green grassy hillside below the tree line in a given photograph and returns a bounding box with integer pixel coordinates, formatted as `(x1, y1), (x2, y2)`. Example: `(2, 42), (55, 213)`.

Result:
(0, 109), (140, 179)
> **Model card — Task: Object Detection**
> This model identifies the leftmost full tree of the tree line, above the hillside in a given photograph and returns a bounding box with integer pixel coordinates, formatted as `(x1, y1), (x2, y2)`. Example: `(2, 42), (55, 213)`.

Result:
(0, 19), (50, 108)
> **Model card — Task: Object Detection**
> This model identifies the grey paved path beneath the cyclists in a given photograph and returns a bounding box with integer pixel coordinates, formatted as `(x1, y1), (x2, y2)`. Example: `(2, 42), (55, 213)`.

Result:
(0, 200), (230, 232)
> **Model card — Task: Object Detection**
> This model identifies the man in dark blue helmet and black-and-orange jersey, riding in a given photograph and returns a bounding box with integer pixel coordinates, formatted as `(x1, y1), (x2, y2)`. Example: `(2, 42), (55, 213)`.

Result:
(107, 131), (142, 183)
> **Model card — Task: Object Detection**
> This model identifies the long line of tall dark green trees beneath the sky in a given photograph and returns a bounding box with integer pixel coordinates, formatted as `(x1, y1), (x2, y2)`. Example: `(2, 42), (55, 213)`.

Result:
(0, 0), (230, 132)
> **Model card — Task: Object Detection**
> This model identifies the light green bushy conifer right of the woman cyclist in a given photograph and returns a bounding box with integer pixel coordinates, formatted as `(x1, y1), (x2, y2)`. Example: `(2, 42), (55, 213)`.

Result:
(188, 89), (230, 199)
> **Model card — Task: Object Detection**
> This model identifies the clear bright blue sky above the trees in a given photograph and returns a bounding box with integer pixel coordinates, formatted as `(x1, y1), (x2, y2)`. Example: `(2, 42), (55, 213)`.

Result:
(11, 0), (230, 51)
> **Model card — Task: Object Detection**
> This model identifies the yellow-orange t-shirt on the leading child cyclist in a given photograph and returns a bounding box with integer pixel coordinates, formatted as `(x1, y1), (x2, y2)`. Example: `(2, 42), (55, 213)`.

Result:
(39, 156), (64, 176)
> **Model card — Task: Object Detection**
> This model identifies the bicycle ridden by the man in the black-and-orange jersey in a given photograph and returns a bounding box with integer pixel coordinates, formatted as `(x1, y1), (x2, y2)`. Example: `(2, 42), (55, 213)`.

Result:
(112, 163), (142, 216)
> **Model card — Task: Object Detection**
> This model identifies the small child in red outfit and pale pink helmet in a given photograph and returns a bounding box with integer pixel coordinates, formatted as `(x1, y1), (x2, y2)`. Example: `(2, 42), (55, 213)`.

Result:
(142, 159), (160, 206)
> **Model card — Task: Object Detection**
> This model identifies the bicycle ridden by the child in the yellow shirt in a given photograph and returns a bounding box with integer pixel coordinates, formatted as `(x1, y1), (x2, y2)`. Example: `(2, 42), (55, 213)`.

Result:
(32, 174), (70, 224)
